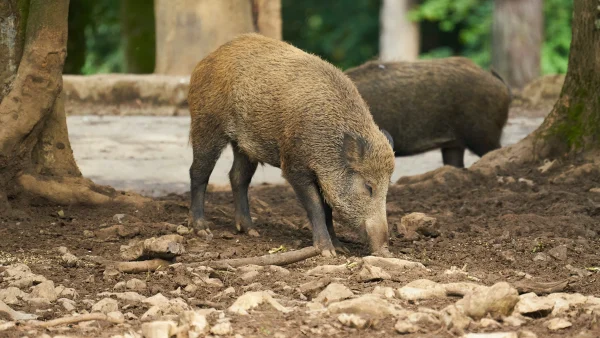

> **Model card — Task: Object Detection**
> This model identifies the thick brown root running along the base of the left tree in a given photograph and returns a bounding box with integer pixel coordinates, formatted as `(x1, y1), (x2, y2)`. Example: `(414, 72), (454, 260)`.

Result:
(18, 174), (151, 207)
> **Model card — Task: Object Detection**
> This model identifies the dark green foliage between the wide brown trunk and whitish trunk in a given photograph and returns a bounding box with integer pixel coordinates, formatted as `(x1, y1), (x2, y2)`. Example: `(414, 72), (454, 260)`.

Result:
(281, 0), (380, 69)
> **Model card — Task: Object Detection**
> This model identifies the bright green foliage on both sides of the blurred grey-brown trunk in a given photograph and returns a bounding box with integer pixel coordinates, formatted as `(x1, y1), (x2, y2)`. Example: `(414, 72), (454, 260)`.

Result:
(409, 0), (573, 74)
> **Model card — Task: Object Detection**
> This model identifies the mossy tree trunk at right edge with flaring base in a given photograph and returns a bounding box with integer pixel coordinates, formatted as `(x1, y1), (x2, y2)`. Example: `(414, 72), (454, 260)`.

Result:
(472, 0), (600, 173)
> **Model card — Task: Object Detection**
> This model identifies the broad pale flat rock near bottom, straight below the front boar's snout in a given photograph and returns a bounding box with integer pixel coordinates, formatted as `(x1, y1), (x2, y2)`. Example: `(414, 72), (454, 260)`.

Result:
(327, 294), (400, 318)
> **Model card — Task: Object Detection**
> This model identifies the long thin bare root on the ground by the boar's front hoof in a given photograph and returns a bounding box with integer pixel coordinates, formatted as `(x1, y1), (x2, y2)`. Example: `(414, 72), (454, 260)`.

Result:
(188, 247), (320, 269)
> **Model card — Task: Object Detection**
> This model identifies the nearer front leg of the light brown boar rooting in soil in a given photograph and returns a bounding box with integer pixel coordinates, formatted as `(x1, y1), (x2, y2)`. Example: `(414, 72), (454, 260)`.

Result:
(286, 172), (336, 257)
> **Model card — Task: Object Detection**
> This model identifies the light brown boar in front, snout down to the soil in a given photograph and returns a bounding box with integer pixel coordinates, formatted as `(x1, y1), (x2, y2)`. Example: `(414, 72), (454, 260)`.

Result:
(188, 33), (394, 255)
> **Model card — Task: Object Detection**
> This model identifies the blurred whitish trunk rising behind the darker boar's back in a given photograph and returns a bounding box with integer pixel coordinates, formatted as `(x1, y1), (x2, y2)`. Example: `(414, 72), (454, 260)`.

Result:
(379, 0), (420, 61)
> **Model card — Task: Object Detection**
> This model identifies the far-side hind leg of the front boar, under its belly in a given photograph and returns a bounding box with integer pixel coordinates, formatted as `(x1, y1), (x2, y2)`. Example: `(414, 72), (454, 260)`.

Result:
(229, 144), (258, 237)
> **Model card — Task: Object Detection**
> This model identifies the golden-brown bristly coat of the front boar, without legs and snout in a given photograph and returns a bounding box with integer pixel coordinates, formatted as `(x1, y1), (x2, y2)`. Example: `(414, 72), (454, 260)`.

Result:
(188, 33), (394, 231)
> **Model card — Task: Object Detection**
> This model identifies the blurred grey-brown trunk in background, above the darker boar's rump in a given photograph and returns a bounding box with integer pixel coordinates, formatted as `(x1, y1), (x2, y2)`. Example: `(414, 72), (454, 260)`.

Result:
(492, 0), (544, 88)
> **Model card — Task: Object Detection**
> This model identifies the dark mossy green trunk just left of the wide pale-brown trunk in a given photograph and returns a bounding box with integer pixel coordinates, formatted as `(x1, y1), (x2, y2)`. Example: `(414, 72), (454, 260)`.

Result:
(121, 0), (156, 74)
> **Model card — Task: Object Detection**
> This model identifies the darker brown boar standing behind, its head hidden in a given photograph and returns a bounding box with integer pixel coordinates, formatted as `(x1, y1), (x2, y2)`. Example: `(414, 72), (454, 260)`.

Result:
(346, 57), (511, 168)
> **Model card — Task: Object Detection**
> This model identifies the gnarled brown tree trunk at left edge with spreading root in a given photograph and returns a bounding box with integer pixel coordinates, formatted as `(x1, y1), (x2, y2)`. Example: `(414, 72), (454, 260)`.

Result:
(0, 0), (148, 210)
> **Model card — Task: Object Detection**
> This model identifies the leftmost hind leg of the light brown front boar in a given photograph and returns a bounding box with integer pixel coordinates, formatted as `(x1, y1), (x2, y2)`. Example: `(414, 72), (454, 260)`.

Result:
(190, 138), (227, 239)
